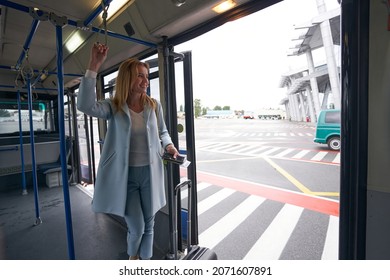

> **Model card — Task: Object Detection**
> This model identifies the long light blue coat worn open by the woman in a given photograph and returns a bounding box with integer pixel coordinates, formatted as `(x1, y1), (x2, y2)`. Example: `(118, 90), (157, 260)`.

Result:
(77, 77), (172, 217)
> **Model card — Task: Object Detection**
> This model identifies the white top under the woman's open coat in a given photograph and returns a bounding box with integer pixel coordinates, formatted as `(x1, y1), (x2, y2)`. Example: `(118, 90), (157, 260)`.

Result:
(129, 109), (150, 166)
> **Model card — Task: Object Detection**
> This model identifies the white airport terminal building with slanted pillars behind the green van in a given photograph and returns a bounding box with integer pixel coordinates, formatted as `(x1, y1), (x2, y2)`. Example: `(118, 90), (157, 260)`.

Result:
(279, 0), (341, 123)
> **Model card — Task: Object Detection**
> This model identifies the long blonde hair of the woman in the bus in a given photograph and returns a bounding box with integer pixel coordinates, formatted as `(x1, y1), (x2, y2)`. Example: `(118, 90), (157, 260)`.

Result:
(112, 58), (157, 111)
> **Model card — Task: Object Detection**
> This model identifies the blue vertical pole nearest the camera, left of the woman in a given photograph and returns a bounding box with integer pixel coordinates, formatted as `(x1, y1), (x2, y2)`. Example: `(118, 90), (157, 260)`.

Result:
(56, 25), (75, 260)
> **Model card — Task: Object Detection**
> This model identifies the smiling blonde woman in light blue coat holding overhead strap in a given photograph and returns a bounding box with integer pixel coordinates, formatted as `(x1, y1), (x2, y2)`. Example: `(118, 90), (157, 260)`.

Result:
(77, 43), (178, 259)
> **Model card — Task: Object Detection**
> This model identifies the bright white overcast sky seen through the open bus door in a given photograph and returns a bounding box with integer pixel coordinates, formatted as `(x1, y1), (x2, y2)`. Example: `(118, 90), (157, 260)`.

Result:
(175, 0), (339, 111)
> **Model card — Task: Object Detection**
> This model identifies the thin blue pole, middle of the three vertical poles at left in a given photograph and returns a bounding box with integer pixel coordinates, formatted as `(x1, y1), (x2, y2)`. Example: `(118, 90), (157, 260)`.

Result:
(26, 77), (42, 225)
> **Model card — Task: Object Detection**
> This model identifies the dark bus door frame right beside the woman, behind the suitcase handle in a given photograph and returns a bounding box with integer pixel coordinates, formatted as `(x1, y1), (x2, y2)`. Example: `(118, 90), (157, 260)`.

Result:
(160, 42), (199, 256)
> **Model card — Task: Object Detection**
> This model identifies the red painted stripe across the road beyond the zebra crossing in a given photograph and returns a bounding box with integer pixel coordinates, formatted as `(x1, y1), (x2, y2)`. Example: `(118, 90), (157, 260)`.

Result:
(180, 168), (339, 217)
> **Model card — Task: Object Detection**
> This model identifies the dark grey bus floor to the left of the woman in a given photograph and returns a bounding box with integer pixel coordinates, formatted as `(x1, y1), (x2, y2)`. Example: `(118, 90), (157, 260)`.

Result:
(0, 186), (137, 260)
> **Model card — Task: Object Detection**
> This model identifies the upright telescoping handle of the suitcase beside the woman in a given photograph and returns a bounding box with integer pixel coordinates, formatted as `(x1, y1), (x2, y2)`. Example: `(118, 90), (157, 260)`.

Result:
(173, 179), (192, 260)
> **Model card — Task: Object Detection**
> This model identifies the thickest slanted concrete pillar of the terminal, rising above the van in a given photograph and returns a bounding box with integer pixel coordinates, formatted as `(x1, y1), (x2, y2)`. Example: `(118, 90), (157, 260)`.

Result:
(317, 0), (341, 109)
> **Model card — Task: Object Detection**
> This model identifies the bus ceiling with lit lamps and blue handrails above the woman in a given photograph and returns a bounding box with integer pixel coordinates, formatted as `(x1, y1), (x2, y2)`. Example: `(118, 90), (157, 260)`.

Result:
(0, 0), (280, 94)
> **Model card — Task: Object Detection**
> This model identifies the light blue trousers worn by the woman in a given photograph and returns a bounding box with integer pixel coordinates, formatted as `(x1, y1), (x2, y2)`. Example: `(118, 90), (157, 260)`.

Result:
(124, 166), (155, 259)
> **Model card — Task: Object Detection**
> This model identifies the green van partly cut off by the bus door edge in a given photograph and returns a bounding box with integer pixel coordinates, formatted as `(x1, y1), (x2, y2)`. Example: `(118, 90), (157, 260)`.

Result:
(314, 109), (341, 151)
